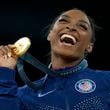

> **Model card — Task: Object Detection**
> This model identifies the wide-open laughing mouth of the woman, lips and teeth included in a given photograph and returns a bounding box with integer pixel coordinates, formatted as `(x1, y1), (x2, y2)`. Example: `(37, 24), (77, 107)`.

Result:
(60, 34), (77, 45)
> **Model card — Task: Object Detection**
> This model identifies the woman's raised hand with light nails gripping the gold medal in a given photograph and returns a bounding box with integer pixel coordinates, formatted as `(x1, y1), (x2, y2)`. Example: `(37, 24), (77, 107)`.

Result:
(0, 45), (18, 69)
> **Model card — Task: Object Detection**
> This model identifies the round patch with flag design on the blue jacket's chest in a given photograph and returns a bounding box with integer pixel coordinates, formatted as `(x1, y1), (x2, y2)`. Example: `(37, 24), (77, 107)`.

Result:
(75, 79), (96, 93)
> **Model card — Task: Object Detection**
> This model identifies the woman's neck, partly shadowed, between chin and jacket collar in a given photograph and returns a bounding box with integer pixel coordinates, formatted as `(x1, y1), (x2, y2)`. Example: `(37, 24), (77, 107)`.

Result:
(51, 56), (82, 69)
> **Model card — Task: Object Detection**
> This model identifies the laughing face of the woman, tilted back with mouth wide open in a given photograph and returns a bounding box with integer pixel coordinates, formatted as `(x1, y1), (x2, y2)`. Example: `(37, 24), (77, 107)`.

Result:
(47, 9), (93, 59)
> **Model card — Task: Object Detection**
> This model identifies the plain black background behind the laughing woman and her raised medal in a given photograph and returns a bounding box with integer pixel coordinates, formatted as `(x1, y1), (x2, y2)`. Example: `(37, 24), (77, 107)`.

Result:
(0, 0), (110, 86)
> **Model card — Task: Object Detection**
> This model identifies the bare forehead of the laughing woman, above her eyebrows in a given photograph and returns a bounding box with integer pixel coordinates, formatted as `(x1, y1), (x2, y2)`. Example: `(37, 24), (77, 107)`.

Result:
(60, 9), (90, 24)
